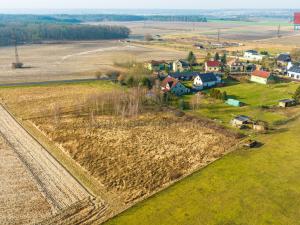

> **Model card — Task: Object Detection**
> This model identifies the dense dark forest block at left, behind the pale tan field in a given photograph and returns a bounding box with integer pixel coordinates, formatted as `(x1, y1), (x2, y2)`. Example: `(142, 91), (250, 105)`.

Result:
(0, 23), (130, 46)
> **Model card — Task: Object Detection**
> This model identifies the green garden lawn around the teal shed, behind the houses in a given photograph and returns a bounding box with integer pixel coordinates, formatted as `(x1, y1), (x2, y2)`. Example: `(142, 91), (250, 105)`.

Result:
(185, 83), (299, 125)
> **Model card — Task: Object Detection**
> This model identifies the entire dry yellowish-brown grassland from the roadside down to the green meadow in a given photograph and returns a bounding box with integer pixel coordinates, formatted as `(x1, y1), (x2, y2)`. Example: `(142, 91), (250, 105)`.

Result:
(0, 82), (238, 220)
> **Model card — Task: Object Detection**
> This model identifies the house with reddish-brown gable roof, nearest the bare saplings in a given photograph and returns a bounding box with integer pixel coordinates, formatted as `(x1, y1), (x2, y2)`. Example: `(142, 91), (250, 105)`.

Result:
(161, 76), (190, 96)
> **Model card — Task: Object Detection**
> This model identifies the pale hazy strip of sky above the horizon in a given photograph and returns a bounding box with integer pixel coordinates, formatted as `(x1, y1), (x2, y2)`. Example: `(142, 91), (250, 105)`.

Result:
(0, 0), (300, 9)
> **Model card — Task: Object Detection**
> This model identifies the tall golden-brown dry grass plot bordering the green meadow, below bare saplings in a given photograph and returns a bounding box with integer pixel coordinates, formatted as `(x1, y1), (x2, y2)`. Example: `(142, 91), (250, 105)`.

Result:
(33, 112), (236, 203)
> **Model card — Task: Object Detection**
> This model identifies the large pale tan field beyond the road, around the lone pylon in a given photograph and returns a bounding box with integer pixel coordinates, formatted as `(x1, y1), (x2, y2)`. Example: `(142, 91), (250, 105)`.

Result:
(0, 41), (186, 84)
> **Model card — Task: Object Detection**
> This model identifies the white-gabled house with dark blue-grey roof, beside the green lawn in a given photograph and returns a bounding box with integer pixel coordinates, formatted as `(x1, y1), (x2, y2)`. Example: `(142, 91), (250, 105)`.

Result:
(193, 73), (222, 90)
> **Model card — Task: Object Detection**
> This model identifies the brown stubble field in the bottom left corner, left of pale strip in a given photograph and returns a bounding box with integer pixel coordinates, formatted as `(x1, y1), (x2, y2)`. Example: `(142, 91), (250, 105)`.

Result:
(0, 135), (52, 225)
